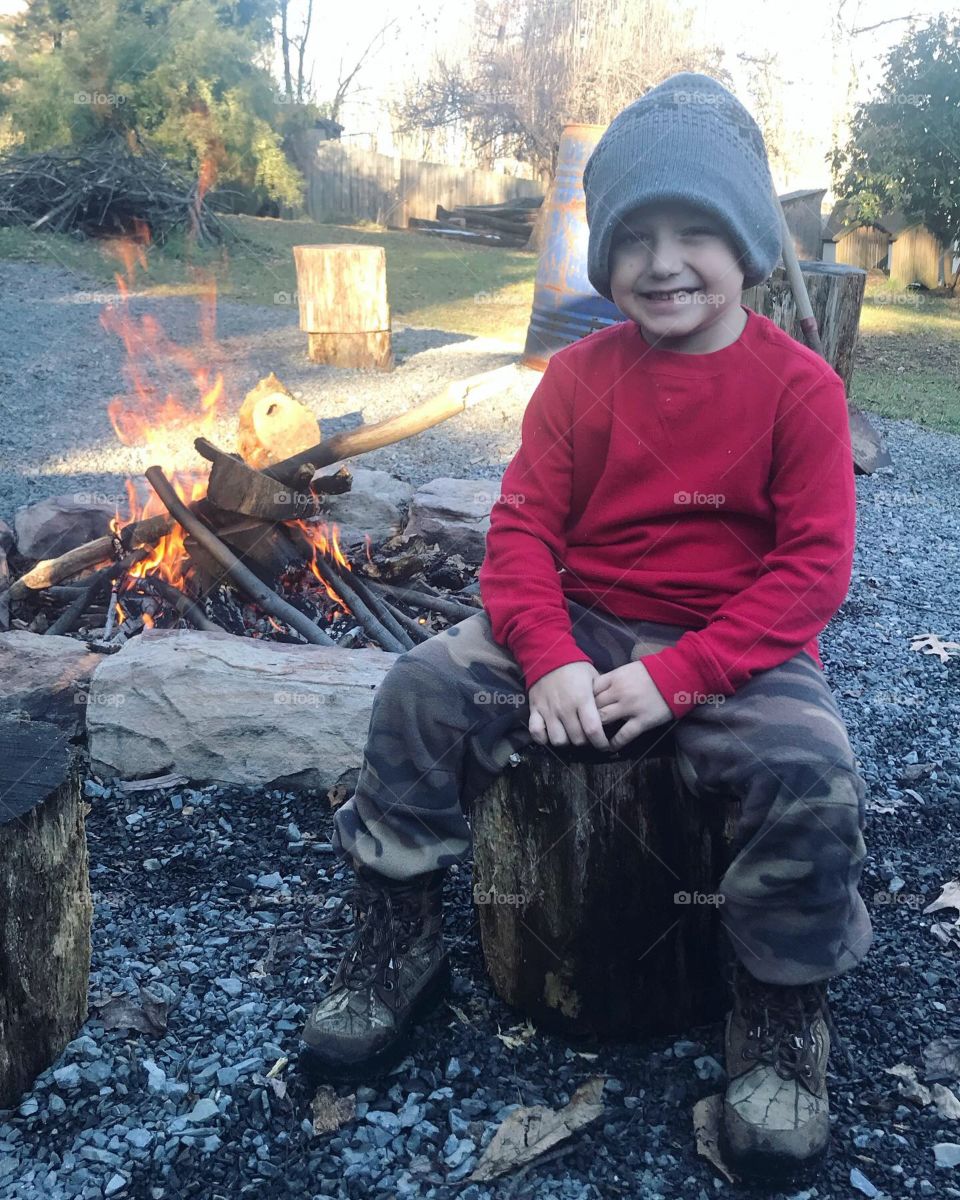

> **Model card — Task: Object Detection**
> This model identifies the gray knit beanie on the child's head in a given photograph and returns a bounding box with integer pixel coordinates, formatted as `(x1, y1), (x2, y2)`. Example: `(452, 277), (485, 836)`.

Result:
(583, 71), (781, 300)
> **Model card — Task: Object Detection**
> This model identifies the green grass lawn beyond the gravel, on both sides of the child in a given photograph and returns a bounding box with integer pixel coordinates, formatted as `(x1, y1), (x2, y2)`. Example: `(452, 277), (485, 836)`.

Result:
(0, 217), (960, 433)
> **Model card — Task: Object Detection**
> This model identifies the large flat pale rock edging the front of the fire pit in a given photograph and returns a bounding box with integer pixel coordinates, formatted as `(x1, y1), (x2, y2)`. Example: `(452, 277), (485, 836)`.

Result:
(86, 629), (397, 788)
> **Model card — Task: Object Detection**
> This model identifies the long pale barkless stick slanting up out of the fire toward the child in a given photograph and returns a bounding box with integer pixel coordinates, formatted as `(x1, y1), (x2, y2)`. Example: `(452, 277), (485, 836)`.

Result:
(263, 362), (516, 485)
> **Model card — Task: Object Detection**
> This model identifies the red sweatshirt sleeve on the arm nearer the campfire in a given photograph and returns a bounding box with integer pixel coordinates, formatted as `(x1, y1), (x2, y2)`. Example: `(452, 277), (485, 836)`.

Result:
(479, 352), (590, 689)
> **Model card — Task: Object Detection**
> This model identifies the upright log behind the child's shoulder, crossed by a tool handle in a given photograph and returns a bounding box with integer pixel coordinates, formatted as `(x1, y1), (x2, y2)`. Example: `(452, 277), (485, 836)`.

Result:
(743, 259), (866, 396)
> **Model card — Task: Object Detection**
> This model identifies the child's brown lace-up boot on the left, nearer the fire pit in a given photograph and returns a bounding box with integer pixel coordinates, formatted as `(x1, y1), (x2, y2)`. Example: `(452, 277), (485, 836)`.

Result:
(300, 866), (450, 1081)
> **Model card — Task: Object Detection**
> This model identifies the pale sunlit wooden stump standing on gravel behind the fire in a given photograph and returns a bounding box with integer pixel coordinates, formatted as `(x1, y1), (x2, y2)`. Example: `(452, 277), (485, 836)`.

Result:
(293, 245), (394, 371)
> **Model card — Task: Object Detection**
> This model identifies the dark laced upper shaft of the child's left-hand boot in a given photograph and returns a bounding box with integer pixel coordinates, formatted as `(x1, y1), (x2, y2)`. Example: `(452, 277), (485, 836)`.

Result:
(341, 876), (436, 991)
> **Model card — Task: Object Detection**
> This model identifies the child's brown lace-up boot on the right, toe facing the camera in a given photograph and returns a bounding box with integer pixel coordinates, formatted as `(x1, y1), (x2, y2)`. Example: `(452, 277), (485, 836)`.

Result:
(720, 960), (833, 1183)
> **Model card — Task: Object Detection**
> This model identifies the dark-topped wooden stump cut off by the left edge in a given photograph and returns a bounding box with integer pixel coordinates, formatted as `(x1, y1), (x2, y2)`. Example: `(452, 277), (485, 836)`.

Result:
(0, 721), (92, 1109)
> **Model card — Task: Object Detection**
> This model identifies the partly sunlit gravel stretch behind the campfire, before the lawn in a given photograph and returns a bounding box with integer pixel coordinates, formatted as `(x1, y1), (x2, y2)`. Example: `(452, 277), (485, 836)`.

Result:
(0, 263), (526, 523)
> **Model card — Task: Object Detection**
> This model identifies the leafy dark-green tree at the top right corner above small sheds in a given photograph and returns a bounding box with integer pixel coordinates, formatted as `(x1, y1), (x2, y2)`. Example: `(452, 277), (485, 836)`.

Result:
(828, 14), (960, 288)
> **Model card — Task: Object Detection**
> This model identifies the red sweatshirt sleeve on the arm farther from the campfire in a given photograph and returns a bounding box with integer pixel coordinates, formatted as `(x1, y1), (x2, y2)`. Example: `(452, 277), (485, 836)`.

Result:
(643, 370), (857, 718)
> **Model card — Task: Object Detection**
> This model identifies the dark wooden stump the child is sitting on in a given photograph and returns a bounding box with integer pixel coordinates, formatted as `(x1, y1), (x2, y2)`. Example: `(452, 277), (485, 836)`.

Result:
(472, 730), (739, 1037)
